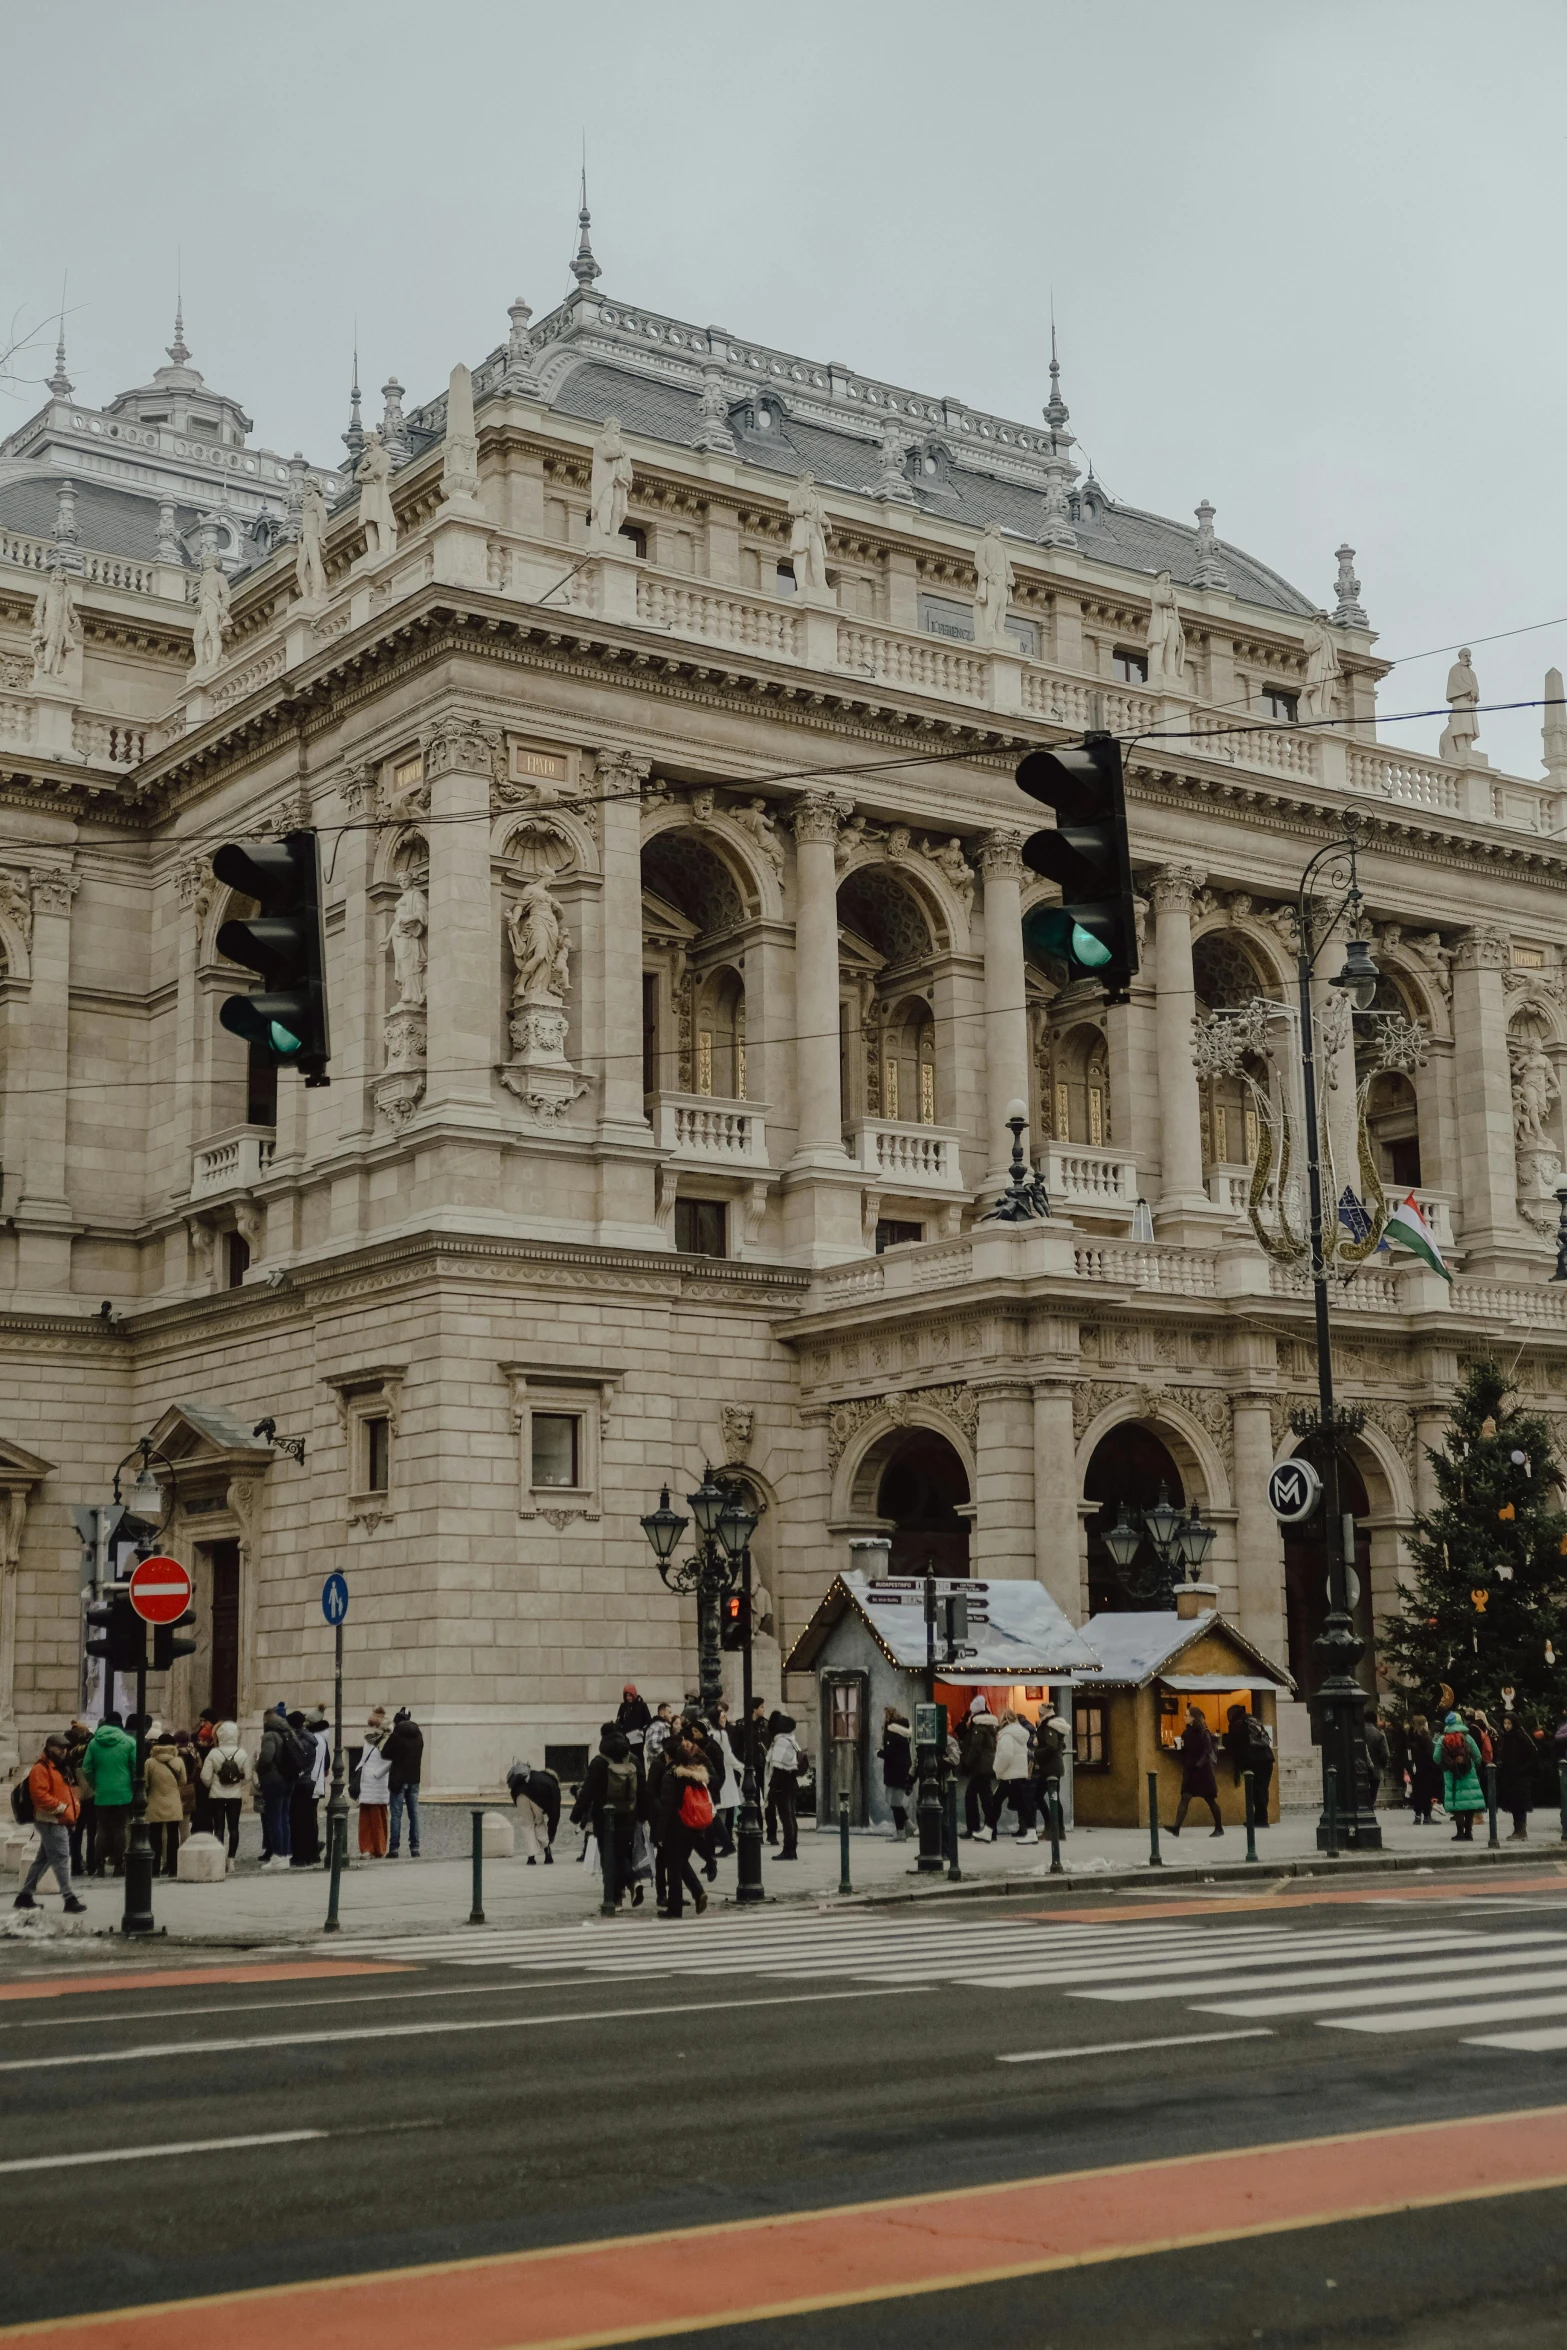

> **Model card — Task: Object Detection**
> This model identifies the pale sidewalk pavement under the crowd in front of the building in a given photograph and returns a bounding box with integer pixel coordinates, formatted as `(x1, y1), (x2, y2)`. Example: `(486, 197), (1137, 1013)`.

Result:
(12, 1805), (1567, 1948)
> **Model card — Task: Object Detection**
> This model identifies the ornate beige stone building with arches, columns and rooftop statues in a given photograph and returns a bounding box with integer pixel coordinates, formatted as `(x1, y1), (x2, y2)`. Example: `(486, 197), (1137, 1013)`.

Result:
(0, 233), (1567, 1788)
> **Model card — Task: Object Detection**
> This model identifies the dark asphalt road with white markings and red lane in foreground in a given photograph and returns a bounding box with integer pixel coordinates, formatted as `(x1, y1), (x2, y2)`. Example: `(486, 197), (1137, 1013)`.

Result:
(0, 1880), (1567, 2350)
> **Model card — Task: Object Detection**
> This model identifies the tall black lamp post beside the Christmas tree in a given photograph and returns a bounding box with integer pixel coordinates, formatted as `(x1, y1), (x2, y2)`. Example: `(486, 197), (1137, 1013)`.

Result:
(1294, 811), (1381, 1852)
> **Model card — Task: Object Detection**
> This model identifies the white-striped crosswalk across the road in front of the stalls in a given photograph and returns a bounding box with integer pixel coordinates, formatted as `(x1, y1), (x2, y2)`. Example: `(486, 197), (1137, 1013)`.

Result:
(322, 1911), (1567, 2054)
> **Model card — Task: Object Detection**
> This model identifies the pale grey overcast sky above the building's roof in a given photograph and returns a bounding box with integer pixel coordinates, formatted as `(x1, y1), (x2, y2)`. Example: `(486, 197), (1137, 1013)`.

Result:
(0, 0), (1567, 773)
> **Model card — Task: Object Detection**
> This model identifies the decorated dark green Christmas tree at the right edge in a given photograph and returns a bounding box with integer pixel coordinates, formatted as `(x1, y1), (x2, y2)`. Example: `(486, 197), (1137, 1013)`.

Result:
(1381, 1363), (1567, 1727)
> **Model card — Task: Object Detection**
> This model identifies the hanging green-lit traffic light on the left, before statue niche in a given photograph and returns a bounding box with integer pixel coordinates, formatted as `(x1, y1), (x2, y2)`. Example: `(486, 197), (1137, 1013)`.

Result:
(211, 832), (331, 1086)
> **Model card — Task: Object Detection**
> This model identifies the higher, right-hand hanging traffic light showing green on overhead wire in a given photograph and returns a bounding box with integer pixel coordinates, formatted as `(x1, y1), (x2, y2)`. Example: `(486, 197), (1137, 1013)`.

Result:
(1017, 733), (1137, 1003)
